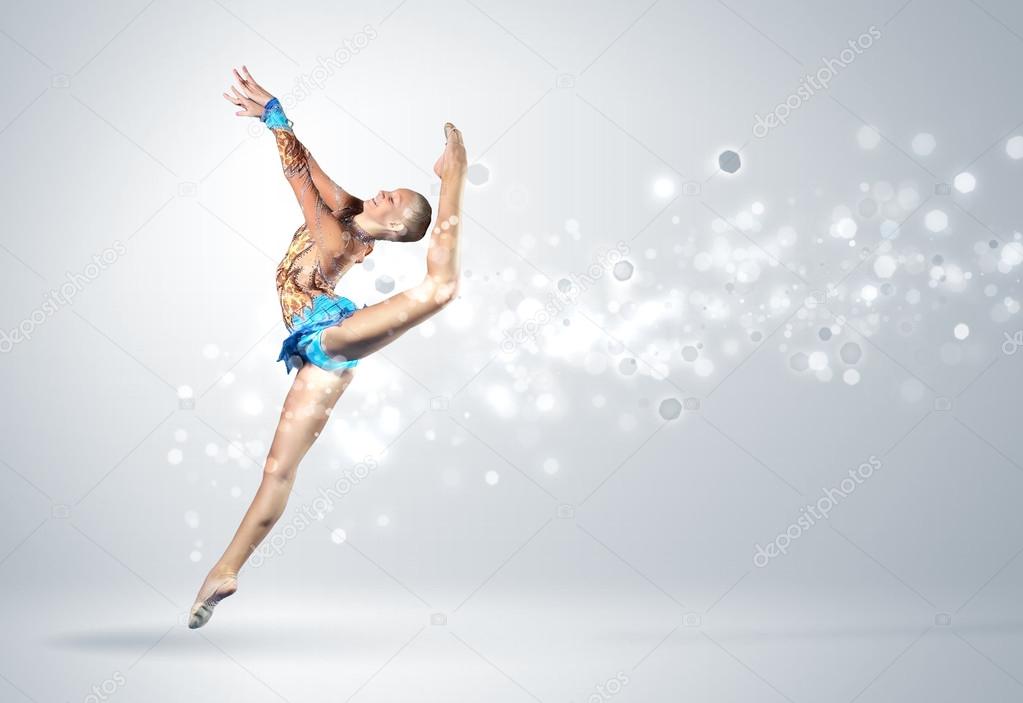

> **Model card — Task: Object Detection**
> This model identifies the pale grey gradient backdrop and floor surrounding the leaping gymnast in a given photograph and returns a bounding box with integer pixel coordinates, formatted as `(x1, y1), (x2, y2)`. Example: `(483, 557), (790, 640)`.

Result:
(0, 0), (1023, 703)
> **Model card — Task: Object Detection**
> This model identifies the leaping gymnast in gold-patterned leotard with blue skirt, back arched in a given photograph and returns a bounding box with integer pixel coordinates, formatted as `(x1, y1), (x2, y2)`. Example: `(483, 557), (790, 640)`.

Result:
(188, 67), (466, 628)
